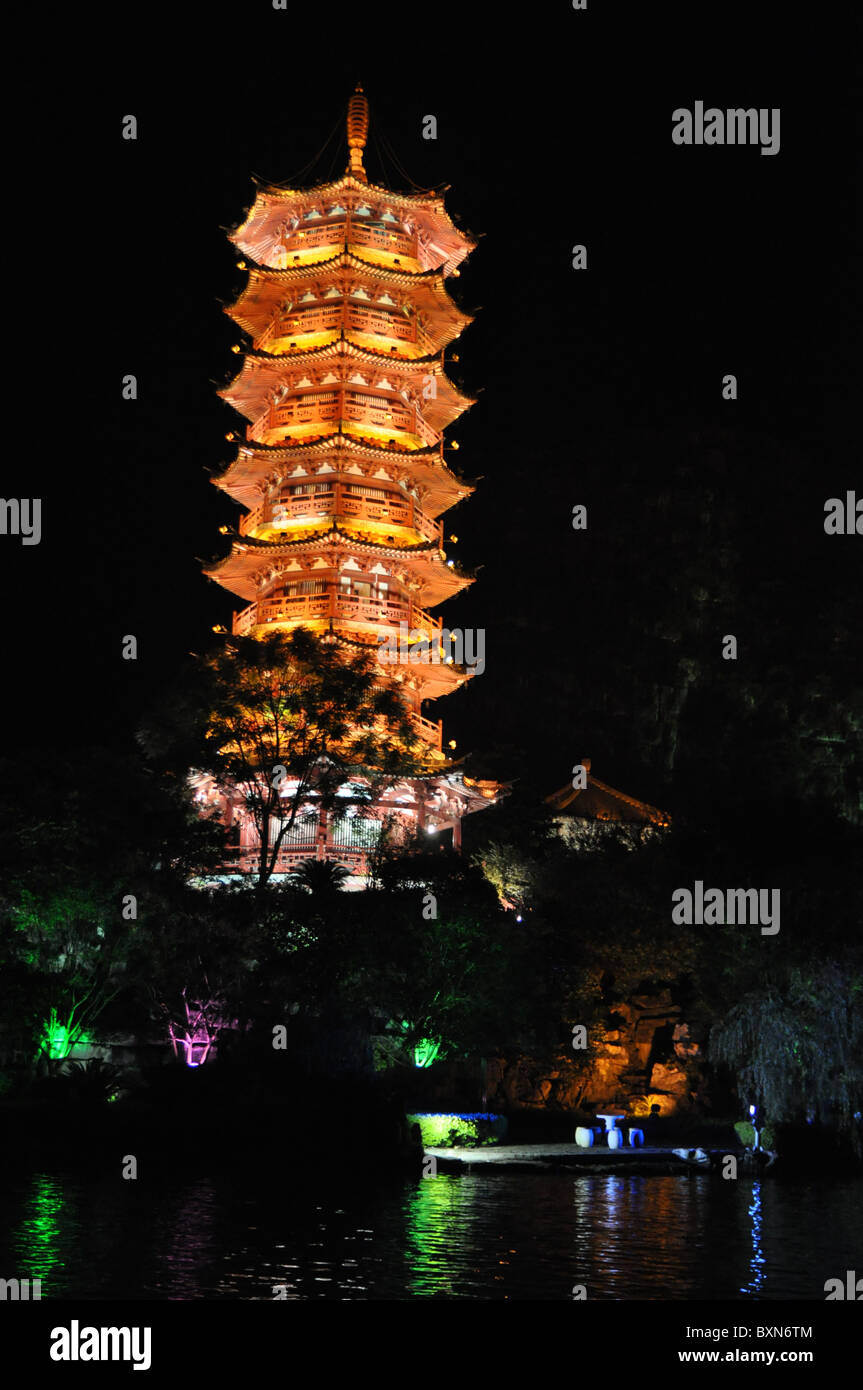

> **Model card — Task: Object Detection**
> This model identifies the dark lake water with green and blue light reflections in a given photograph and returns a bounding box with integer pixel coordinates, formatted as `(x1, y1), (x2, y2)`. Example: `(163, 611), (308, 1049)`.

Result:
(0, 1169), (863, 1301)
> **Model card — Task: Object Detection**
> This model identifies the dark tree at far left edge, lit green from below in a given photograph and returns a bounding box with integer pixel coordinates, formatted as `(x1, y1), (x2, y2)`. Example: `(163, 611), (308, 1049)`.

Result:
(0, 746), (220, 1063)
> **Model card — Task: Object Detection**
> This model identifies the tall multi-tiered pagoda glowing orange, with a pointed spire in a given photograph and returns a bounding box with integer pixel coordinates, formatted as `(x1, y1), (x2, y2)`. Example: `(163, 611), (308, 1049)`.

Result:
(196, 88), (500, 885)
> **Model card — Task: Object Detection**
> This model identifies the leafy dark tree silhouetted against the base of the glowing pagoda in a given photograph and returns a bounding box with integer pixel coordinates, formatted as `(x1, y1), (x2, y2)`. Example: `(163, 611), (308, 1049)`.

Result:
(140, 628), (431, 888)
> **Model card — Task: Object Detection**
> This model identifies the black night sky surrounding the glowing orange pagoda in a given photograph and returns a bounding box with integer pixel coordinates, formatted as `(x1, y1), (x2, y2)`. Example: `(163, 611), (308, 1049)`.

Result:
(1, 0), (863, 805)
